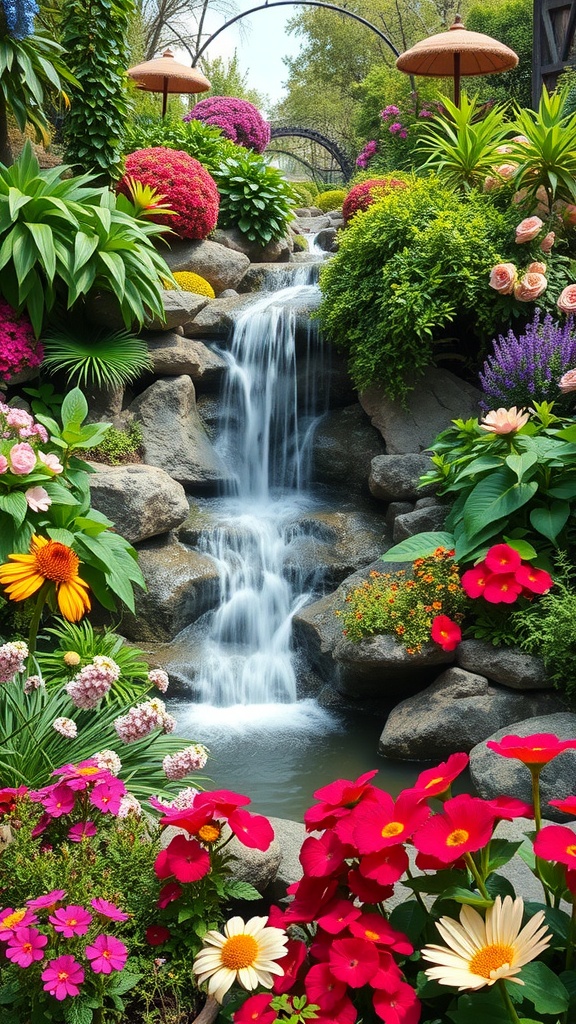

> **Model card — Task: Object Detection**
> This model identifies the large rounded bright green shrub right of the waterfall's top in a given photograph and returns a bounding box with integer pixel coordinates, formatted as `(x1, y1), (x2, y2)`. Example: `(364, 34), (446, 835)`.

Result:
(319, 178), (517, 398)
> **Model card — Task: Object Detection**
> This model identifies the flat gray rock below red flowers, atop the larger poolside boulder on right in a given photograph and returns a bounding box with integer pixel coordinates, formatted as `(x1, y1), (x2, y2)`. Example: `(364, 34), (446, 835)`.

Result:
(456, 640), (552, 690)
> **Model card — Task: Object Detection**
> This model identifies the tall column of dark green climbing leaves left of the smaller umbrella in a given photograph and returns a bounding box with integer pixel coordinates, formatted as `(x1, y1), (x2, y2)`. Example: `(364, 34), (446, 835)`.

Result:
(63, 0), (134, 183)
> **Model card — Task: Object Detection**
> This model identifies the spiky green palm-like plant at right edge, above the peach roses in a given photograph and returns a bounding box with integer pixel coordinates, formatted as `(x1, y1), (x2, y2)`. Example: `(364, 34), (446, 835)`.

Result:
(509, 87), (576, 211)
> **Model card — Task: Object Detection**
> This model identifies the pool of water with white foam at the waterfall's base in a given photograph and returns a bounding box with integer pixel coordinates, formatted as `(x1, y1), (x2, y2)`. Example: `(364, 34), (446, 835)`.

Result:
(170, 699), (423, 821)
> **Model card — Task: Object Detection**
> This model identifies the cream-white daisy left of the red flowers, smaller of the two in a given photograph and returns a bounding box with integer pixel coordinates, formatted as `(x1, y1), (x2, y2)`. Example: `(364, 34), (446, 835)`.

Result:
(193, 918), (288, 1002)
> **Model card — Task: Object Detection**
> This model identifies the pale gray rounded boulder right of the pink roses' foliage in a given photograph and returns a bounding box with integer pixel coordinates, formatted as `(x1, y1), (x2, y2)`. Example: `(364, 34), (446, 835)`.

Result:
(89, 463), (189, 544)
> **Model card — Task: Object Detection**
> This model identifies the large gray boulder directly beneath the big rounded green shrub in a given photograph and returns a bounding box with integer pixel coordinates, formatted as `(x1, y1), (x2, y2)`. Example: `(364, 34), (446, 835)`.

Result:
(360, 367), (482, 455)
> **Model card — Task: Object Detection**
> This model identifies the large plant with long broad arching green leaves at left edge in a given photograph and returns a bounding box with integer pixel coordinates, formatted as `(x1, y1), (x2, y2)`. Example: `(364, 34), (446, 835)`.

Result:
(0, 142), (170, 335)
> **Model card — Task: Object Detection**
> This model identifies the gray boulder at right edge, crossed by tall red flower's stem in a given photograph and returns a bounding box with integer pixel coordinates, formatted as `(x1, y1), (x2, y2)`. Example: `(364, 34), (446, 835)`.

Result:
(470, 712), (576, 822)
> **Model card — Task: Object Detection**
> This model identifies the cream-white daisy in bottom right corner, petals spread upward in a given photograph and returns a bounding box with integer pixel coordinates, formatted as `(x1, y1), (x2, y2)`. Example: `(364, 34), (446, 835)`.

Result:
(422, 896), (551, 991)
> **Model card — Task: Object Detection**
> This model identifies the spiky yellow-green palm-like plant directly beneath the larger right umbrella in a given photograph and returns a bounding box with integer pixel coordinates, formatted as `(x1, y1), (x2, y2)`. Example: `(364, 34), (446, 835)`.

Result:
(417, 93), (507, 189)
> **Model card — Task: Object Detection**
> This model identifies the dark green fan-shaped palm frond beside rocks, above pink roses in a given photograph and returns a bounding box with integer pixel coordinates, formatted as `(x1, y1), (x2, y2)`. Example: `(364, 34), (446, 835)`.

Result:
(43, 324), (152, 390)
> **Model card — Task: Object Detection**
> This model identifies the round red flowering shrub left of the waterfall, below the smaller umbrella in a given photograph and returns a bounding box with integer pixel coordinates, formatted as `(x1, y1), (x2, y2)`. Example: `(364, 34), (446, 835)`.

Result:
(118, 146), (219, 239)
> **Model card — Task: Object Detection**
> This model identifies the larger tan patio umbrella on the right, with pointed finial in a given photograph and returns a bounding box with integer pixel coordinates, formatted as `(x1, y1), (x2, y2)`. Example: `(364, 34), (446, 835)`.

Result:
(396, 14), (518, 105)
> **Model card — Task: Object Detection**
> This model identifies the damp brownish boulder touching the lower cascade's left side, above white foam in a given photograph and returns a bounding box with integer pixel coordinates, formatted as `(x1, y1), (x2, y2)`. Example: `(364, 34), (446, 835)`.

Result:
(122, 537), (219, 643)
